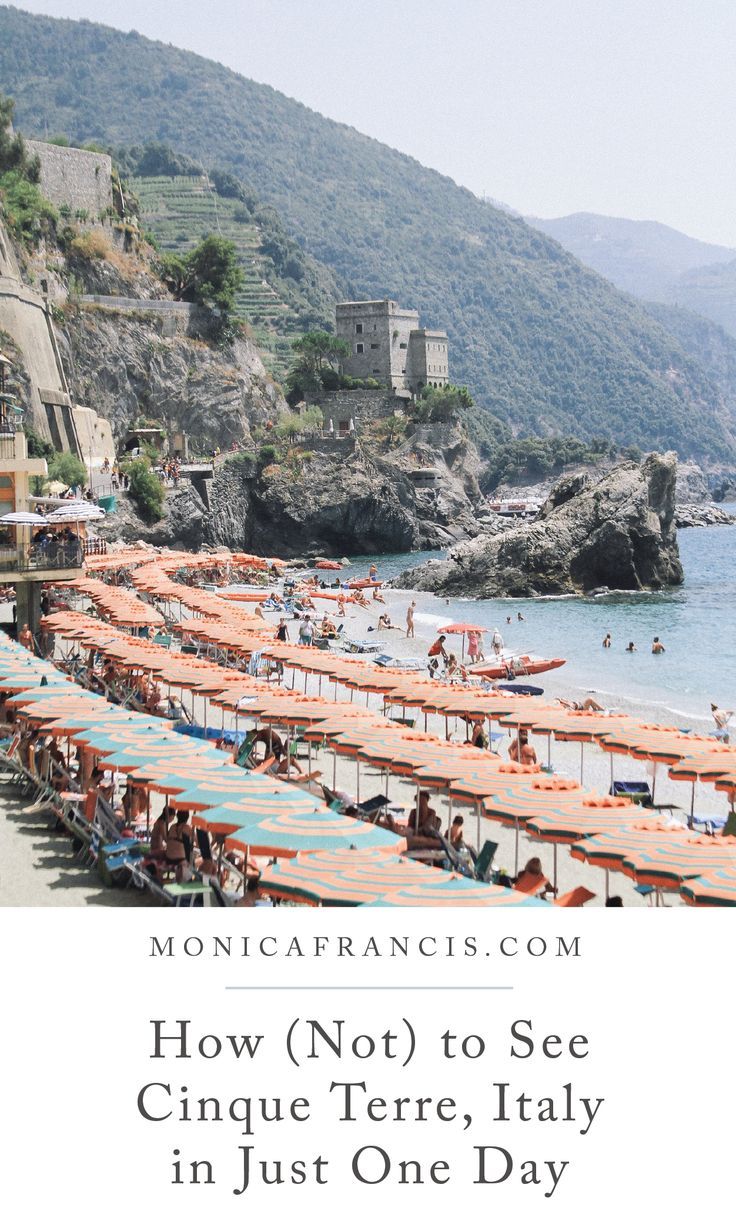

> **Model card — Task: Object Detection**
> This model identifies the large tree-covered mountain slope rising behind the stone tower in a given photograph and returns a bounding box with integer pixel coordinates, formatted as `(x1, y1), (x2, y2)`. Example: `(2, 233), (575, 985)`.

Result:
(0, 7), (734, 458)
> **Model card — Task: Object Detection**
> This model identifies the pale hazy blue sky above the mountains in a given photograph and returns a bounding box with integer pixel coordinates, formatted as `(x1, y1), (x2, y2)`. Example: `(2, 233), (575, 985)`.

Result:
(16, 0), (736, 247)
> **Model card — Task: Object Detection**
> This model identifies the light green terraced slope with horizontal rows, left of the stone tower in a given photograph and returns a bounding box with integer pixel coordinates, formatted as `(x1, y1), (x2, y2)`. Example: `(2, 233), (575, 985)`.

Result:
(128, 174), (333, 379)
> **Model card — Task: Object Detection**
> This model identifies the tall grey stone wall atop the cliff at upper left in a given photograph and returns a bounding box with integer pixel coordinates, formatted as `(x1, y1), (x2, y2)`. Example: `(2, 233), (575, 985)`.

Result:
(26, 141), (113, 222)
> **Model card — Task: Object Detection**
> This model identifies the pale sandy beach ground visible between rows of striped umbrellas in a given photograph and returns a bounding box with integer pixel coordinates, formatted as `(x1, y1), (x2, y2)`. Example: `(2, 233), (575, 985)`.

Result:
(0, 569), (727, 907)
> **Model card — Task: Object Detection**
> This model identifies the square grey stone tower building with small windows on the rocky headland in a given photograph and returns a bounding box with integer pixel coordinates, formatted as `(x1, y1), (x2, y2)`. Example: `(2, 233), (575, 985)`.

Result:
(335, 298), (450, 398)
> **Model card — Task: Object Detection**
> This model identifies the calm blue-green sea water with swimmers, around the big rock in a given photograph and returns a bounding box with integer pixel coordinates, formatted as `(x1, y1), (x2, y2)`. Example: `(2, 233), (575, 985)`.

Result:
(335, 508), (736, 720)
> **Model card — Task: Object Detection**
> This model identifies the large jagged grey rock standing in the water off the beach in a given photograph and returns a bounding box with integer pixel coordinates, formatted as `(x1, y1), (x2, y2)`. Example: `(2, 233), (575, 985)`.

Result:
(394, 452), (683, 597)
